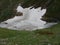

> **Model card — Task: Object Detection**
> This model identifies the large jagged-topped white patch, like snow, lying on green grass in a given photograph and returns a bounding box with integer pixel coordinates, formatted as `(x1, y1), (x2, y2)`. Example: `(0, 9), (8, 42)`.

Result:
(0, 6), (56, 30)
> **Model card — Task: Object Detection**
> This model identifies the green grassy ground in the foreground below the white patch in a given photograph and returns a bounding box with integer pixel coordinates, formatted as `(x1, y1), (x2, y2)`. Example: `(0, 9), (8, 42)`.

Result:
(0, 24), (60, 45)
